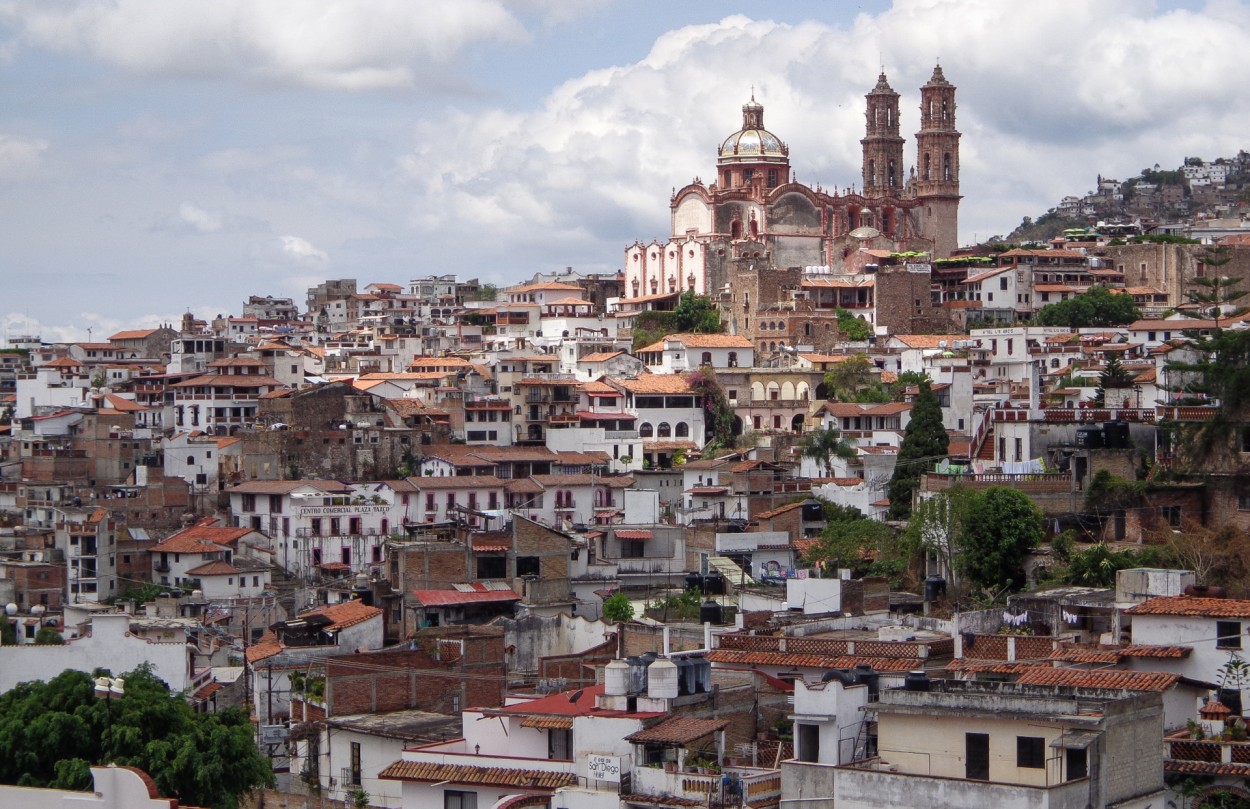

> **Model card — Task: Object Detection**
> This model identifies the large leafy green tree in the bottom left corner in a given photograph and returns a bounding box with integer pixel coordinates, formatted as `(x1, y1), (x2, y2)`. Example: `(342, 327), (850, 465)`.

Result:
(0, 666), (274, 809)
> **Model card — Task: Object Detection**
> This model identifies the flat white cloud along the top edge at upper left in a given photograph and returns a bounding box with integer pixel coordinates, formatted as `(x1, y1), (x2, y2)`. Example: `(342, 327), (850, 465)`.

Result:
(0, 0), (526, 90)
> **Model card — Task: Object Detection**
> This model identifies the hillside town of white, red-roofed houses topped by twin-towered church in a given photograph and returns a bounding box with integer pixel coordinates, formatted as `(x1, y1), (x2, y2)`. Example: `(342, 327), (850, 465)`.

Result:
(7, 66), (1250, 809)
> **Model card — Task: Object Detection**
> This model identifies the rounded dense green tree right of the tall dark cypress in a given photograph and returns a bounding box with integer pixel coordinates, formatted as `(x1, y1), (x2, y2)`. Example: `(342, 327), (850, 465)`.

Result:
(956, 486), (1043, 591)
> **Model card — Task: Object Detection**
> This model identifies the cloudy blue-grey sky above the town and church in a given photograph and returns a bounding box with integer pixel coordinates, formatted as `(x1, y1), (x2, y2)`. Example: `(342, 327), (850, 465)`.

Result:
(0, 0), (1250, 341)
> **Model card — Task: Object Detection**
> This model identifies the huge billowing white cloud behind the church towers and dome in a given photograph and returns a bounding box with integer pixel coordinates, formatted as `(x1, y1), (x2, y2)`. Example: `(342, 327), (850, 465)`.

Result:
(401, 0), (1250, 252)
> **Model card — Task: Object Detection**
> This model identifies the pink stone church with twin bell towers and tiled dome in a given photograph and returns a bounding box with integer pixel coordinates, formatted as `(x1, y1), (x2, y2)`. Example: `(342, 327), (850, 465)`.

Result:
(620, 66), (960, 351)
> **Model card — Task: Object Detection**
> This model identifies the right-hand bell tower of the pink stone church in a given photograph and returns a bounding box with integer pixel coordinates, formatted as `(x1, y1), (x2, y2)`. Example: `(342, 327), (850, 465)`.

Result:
(915, 65), (961, 259)
